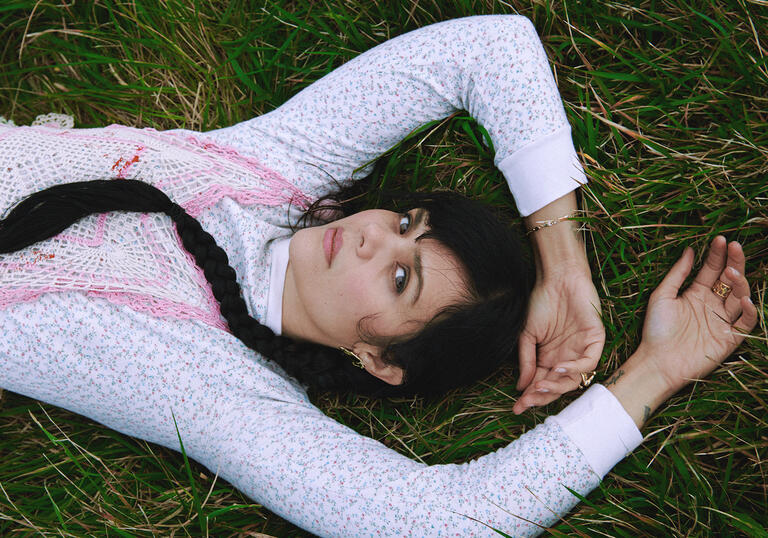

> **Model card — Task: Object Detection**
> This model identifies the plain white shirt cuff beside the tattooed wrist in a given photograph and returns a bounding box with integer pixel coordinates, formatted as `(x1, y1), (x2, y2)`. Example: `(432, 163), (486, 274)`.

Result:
(552, 385), (643, 479)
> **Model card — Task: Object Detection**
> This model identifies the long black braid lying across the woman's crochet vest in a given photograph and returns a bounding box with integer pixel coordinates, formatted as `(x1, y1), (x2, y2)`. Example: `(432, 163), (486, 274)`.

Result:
(0, 179), (385, 392)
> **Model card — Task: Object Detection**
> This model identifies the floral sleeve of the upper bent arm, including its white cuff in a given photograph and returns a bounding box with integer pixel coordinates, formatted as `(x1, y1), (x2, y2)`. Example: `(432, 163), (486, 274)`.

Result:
(207, 15), (586, 215)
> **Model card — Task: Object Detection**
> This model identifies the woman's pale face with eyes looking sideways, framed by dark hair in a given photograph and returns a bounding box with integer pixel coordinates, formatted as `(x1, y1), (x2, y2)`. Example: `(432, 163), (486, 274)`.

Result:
(283, 209), (466, 378)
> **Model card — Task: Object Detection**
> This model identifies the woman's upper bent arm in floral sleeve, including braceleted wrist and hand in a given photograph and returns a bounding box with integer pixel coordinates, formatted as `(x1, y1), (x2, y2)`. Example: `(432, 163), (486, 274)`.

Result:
(209, 11), (605, 418)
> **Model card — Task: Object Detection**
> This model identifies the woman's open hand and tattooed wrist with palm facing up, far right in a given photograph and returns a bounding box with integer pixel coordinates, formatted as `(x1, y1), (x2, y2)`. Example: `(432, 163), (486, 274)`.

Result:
(603, 236), (757, 427)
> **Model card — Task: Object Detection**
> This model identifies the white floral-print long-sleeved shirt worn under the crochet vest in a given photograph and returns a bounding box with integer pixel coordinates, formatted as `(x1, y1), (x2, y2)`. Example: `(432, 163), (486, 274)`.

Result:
(0, 16), (640, 537)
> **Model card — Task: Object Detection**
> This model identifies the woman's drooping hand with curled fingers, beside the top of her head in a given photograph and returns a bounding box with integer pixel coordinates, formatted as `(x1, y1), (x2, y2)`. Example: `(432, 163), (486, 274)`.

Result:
(513, 268), (605, 413)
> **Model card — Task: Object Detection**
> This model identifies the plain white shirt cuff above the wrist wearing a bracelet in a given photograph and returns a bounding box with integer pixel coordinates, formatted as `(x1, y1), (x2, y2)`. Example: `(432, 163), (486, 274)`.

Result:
(498, 127), (587, 217)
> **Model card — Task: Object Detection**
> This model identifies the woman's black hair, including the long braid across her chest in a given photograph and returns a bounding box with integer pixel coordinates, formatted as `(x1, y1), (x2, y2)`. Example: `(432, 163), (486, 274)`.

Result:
(0, 180), (531, 396)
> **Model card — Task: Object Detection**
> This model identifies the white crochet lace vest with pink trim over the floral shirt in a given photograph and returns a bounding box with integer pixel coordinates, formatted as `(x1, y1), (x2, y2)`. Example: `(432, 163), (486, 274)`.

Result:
(0, 114), (307, 329)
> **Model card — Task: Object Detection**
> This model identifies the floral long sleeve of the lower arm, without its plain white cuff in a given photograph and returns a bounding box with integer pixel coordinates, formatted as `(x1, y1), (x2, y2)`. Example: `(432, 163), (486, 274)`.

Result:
(0, 293), (640, 536)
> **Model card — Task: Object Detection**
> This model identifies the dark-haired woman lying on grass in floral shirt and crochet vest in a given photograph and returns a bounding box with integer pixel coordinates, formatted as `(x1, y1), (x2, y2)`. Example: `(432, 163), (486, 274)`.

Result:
(0, 16), (756, 536)
